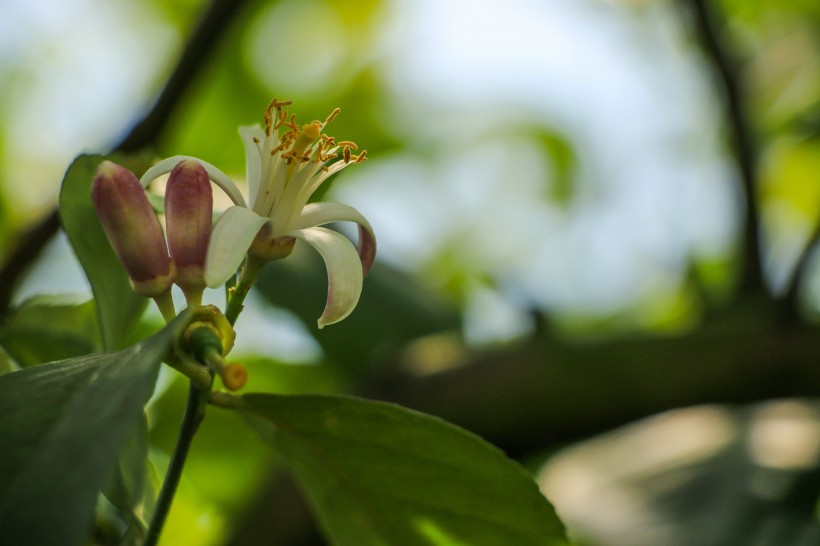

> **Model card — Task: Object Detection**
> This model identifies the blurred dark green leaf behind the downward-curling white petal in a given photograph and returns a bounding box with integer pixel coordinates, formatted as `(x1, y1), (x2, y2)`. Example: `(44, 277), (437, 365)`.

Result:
(257, 248), (460, 371)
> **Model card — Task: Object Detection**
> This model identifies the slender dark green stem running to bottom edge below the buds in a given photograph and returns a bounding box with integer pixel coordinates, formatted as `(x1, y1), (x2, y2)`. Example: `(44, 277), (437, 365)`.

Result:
(143, 381), (211, 546)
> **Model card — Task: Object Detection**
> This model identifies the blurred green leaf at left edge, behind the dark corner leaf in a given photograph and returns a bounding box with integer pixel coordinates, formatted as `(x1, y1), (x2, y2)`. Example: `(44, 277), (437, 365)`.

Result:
(0, 296), (100, 366)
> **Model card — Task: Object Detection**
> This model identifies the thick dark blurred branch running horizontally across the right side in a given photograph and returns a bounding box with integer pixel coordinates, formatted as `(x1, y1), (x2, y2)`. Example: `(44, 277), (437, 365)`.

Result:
(363, 307), (820, 456)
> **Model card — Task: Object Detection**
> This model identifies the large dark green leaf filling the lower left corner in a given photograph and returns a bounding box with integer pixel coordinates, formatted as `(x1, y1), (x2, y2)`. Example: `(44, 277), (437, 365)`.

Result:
(0, 314), (189, 546)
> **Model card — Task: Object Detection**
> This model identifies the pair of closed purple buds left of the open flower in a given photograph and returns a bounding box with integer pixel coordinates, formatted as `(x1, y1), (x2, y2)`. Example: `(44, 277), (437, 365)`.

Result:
(91, 160), (213, 319)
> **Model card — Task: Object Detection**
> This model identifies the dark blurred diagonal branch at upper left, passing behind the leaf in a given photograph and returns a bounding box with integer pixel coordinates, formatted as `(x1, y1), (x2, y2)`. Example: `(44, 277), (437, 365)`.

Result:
(0, 0), (245, 314)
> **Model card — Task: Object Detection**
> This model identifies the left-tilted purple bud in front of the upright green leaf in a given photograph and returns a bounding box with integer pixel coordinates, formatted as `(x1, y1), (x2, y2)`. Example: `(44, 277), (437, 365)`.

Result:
(91, 161), (175, 298)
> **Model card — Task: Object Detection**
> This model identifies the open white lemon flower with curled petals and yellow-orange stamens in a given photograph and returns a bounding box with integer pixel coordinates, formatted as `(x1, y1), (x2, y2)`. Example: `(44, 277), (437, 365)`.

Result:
(141, 99), (376, 328)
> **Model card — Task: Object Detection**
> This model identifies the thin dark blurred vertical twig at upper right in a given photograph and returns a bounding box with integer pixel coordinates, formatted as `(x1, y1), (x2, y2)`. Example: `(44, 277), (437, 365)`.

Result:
(685, 0), (764, 295)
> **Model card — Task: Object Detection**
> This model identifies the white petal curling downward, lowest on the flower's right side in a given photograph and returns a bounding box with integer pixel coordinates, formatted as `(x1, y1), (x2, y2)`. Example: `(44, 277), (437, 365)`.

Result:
(288, 227), (363, 328)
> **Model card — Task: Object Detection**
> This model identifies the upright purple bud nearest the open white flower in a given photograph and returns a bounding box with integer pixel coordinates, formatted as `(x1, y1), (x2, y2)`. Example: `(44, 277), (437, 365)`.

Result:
(165, 160), (214, 305)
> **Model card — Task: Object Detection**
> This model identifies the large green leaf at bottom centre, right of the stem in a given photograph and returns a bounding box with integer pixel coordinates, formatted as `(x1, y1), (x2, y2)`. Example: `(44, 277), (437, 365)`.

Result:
(229, 394), (566, 546)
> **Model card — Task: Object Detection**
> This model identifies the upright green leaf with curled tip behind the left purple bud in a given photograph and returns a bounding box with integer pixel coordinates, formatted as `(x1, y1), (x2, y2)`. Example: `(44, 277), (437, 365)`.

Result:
(60, 155), (153, 350)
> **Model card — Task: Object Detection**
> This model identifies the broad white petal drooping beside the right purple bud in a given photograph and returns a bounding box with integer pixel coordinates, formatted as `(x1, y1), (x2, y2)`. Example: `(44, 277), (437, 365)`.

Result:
(205, 207), (268, 288)
